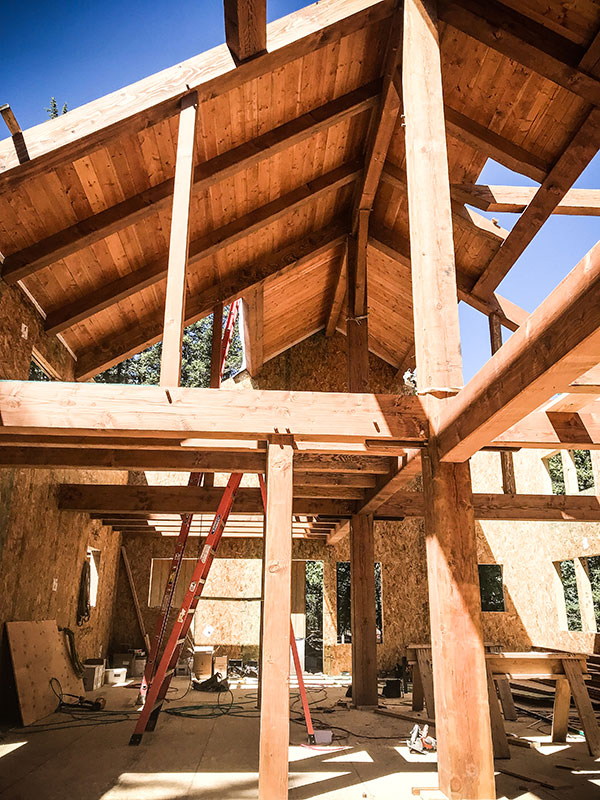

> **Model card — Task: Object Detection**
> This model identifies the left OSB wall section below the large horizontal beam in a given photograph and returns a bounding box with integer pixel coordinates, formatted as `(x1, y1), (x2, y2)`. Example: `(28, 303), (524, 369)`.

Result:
(0, 469), (127, 708)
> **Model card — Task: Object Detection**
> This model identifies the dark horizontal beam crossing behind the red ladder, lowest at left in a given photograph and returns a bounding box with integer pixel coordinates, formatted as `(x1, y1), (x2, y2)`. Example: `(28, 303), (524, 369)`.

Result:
(58, 484), (354, 516)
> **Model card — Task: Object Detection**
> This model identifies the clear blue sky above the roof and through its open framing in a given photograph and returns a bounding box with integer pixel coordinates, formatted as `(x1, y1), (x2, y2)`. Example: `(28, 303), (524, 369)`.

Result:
(0, 0), (600, 380)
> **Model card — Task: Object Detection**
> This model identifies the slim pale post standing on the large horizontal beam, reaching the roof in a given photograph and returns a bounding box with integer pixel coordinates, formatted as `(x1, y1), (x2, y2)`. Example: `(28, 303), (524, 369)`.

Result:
(160, 92), (198, 386)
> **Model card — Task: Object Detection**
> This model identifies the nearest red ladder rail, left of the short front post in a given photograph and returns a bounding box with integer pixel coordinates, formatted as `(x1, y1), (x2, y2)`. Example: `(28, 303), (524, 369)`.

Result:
(129, 472), (242, 745)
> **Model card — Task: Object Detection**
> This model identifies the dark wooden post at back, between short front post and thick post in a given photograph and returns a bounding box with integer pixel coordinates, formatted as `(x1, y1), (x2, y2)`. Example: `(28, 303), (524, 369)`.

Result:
(350, 514), (377, 706)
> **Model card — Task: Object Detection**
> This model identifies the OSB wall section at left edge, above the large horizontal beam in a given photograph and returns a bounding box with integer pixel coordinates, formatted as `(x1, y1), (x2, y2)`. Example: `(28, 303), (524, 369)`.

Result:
(0, 279), (75, 381)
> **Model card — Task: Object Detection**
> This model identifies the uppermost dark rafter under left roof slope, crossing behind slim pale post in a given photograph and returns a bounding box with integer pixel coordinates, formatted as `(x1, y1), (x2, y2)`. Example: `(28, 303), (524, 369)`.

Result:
(2, 81), (381, 283)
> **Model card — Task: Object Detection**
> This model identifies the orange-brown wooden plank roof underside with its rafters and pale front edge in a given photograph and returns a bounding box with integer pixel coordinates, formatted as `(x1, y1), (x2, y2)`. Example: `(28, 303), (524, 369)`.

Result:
(0, 0), (600, 379)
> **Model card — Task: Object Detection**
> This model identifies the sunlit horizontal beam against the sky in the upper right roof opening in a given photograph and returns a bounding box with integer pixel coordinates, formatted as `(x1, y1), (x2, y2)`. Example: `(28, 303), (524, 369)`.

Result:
(451, 183), (600, 217)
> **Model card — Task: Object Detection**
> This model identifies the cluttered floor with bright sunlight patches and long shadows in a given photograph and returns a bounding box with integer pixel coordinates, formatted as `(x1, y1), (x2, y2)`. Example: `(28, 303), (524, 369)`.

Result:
(0, 678), (600, 800)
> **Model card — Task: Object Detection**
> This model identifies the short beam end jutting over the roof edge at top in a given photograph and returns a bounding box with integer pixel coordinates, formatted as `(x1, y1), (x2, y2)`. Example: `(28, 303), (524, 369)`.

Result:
(223, 0), (267, 65)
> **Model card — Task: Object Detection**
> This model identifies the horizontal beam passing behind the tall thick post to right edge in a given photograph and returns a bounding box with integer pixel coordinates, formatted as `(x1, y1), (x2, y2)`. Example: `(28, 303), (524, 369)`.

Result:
(377, 492), (600, 522)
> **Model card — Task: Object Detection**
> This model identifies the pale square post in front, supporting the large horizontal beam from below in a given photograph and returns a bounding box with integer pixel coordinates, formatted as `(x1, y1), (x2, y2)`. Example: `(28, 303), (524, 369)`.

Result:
(258, 443), (293, 800)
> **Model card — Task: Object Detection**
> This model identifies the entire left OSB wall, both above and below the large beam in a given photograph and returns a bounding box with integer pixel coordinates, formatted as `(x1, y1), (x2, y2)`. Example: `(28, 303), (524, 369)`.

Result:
(0, 280), (127, 720)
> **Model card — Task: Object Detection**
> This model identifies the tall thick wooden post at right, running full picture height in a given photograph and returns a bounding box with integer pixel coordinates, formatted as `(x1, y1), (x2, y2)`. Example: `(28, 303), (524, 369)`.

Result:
(402, 0), (496, 800)
